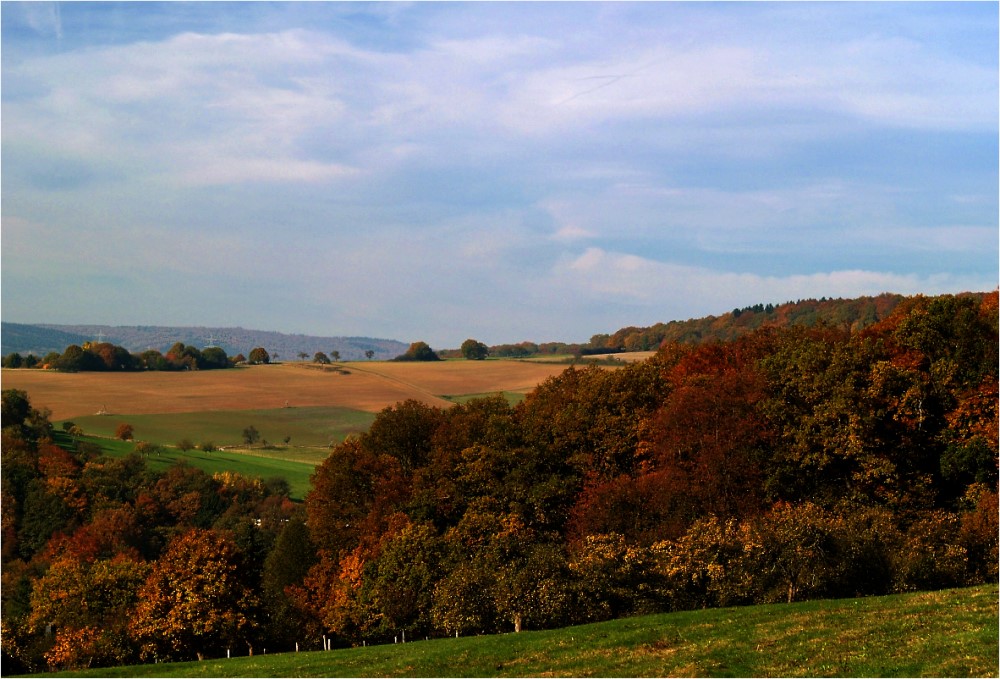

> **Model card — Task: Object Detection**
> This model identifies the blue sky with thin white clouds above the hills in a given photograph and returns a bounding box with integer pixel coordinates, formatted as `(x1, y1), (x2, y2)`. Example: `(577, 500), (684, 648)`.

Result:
(0, 0), (1000, 349)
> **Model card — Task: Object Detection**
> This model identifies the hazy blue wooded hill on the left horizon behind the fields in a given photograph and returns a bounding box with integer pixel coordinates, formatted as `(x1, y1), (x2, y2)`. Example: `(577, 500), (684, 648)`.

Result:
(0, 322), (409, 361)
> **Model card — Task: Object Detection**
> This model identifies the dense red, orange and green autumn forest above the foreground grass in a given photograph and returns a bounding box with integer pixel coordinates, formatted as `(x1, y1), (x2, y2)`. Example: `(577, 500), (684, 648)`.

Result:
(0, 292), (1000, 674)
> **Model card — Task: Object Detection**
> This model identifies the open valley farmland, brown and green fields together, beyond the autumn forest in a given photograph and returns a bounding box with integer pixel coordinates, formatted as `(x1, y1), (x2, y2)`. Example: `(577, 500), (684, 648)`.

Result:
(2, 360), (584, 500)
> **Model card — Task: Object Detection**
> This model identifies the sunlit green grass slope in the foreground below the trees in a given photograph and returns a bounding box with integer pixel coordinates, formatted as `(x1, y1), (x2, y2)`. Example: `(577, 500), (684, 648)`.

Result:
(27, 585), (1000, 677)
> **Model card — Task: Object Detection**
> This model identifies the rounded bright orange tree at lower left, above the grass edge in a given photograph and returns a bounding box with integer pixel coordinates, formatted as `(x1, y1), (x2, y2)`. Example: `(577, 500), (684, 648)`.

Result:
(129, 529), (258, 660)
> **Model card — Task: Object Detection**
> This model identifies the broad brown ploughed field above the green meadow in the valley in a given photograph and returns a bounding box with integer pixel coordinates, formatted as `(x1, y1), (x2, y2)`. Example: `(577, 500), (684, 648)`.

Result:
(0, 361), (580, 420)
